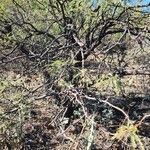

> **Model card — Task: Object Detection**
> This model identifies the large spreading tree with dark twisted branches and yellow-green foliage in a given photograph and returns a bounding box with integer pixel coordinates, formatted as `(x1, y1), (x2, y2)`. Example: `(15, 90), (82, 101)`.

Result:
(0, 0), (150, 89)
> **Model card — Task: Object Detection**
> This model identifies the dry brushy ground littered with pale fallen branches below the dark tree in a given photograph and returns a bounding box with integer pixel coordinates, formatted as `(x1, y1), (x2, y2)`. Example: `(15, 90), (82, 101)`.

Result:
(0, 47), (150, 150)
